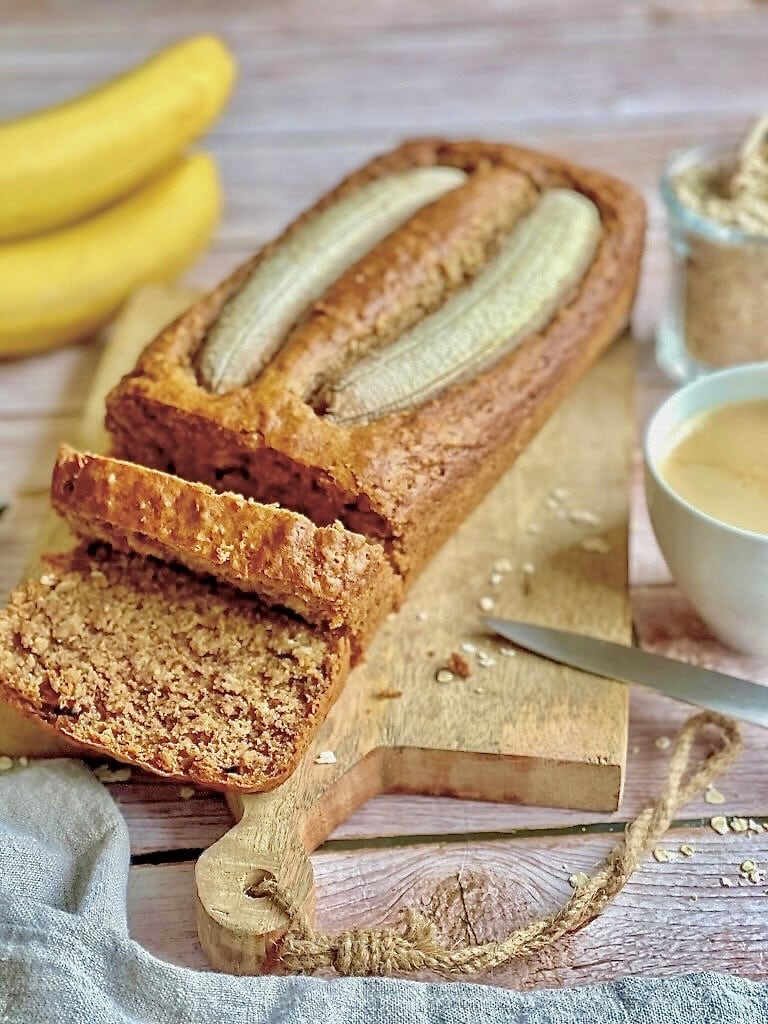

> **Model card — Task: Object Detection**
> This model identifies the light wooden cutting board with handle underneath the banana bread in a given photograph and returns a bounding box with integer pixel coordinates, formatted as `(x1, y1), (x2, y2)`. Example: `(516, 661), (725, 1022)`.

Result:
(0, 290), (633, 973)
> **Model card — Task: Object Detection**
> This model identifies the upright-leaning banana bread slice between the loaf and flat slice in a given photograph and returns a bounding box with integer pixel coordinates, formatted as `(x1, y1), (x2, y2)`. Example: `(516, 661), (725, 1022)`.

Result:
(51, 444), (401, 651)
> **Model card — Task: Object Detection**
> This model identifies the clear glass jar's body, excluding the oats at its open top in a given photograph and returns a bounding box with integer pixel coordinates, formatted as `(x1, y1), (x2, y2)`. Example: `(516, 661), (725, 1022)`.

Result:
(656, 138), (768, 381)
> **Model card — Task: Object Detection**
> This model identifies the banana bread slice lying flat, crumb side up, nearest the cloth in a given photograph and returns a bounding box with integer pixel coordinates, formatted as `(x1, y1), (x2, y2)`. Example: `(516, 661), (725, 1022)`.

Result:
(0, 546), (349, 792)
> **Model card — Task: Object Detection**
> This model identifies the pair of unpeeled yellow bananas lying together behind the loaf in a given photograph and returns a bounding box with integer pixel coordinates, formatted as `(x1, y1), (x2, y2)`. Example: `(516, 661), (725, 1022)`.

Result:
(0, 36), (234, 357)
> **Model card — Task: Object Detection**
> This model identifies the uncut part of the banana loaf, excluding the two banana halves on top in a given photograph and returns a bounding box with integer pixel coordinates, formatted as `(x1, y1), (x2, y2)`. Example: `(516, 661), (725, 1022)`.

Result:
(106, 139), (645, 583)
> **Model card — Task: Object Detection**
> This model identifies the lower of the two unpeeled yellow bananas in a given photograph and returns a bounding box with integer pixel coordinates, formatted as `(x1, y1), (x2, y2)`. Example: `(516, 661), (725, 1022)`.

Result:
(0, 154), (220, 357)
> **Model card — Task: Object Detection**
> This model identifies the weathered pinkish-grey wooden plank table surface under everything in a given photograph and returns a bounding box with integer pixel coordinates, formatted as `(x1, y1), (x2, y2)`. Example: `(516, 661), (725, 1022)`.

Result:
(0, 0), (768, 987)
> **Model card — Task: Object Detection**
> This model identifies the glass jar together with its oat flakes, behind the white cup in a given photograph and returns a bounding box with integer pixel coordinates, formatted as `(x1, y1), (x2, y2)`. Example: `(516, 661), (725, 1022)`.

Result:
(656, 119), (768, 381)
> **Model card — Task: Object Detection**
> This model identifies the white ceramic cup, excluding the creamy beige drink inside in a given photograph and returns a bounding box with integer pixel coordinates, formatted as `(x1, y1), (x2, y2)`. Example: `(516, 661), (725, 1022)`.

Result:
(644, 362), (768, 657)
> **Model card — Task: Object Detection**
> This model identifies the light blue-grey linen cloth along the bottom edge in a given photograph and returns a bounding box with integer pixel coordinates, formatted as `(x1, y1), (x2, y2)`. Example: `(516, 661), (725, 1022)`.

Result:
(0, 761), (768, 1024)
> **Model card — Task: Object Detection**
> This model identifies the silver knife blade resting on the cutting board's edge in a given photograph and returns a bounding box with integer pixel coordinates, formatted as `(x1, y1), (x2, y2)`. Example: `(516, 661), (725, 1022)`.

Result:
(482, 618), (768, 728)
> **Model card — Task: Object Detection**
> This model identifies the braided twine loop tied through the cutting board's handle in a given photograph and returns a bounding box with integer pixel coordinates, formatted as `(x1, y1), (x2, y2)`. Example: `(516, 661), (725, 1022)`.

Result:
(257, 712), (741, 976)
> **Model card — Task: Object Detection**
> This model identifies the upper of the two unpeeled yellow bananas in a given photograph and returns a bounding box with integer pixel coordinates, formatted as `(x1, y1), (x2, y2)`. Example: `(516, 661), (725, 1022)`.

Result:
(0, 36), (234, 240)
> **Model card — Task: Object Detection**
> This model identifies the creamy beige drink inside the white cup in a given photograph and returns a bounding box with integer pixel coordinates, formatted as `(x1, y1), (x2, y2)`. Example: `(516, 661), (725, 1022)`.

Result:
(658, 398), (768, 535)
